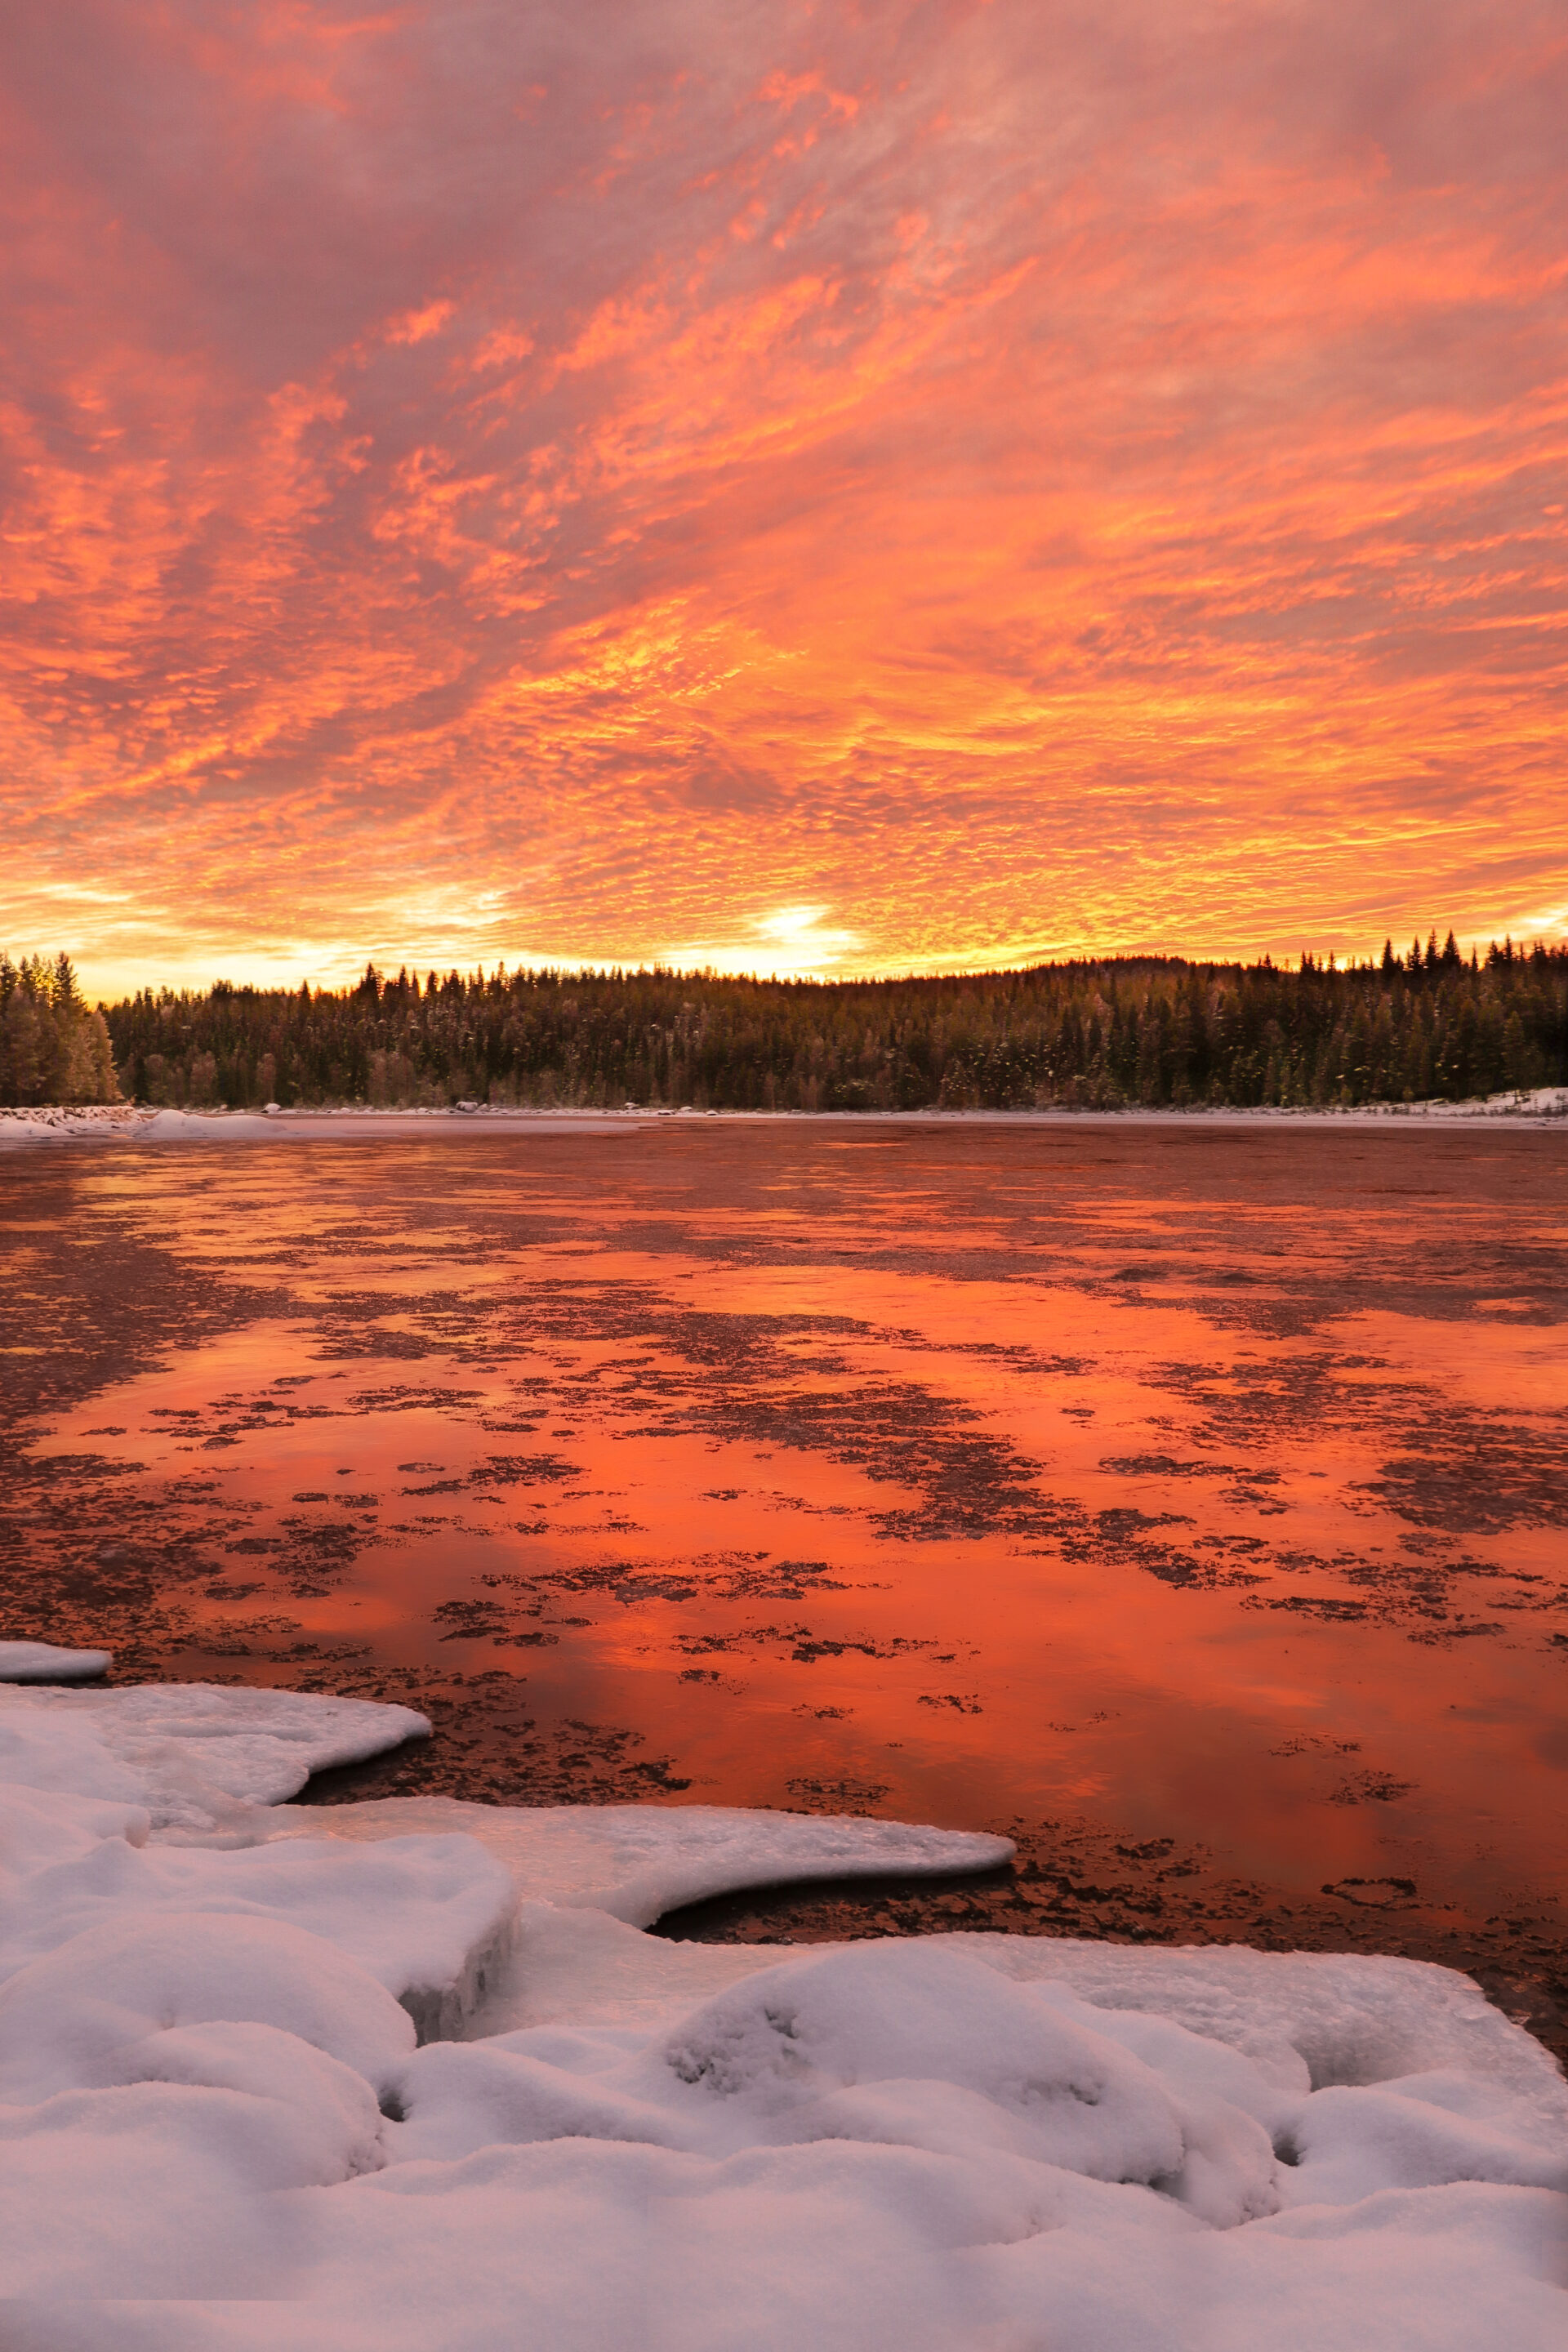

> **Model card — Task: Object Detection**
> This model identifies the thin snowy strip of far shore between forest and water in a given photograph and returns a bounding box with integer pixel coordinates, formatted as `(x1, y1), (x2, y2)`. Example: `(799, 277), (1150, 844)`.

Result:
(0, 1087), (1568, 1152)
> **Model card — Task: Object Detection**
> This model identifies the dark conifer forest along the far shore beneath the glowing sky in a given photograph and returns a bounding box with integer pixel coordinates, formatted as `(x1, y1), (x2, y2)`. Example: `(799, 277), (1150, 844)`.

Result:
(0, 933), (1568, 1110)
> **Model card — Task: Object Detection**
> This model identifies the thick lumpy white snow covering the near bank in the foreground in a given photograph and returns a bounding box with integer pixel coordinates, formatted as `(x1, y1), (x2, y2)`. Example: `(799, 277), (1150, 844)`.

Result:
(0, 1686), (1568, 2352)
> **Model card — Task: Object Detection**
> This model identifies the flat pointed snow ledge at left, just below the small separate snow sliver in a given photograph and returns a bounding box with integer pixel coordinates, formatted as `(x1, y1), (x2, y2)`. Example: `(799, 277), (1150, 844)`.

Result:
(0, 1682), (430, 1834)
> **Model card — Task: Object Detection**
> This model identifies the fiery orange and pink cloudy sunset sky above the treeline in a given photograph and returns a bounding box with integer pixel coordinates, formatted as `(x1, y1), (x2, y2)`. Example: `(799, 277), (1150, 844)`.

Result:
(0, 0), (1568, 995)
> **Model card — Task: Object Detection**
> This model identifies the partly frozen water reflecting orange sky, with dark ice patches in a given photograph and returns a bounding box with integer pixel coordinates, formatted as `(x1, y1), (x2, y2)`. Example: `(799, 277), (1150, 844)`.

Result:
(0, 1120), (1568, 2039)
